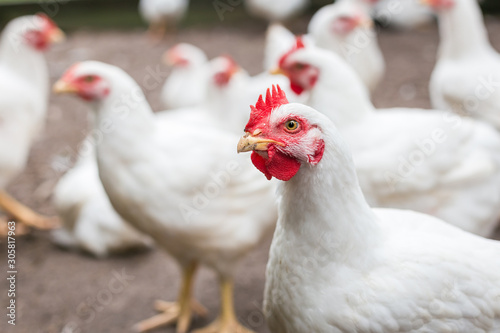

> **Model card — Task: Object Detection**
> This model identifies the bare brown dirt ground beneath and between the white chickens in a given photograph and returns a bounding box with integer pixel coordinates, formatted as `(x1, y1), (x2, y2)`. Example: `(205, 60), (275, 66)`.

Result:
(0, 17), (500, 333)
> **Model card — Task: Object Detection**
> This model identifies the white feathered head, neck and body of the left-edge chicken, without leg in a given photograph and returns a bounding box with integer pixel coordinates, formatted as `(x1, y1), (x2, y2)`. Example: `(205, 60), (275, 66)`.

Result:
(0, 16), (49, 189)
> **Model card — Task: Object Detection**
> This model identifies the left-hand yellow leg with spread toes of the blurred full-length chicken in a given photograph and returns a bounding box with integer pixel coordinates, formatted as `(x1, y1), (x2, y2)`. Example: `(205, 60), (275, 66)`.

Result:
(134, 262), (207, 333)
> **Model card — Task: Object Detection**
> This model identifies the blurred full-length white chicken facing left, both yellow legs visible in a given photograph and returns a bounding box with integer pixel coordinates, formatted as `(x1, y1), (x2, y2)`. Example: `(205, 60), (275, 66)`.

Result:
(54, 61), (276, 333)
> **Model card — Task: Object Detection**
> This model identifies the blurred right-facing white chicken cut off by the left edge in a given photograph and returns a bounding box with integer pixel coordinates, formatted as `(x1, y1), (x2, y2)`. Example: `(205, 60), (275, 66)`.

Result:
(0, 14), (64, 229)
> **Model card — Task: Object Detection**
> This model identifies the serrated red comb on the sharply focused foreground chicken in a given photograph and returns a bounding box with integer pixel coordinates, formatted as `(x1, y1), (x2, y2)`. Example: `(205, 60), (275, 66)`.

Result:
(245, 85), (288, 132)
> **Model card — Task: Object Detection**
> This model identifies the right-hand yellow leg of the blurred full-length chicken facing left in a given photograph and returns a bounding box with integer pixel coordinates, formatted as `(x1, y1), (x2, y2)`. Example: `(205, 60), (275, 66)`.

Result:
(193, 277), (254, 333)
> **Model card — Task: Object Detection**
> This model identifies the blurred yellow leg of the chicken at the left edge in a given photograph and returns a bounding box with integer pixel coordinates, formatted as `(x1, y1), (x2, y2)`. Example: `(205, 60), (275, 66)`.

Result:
(0, 190), (60, 229)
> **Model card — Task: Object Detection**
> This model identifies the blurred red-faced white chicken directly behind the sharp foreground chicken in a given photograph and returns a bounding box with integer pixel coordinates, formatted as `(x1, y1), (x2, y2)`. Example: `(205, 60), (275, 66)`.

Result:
(274, 39), (500, 236)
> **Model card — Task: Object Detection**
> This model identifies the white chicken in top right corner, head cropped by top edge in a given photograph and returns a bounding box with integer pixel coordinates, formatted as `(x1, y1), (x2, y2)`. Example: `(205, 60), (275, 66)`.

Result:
(426, 0), (500, 130)
